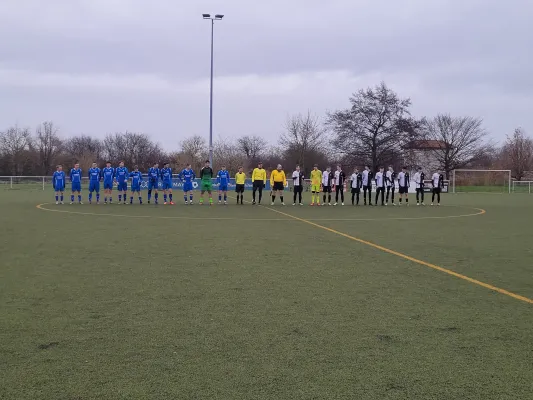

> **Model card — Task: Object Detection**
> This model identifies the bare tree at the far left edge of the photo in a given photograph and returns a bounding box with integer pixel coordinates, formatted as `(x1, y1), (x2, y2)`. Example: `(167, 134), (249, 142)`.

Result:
(0, 126), (33, 175)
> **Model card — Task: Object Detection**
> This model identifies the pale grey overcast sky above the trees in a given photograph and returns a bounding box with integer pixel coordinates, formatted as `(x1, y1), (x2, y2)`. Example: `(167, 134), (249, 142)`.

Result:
(0, 0), (533, 149)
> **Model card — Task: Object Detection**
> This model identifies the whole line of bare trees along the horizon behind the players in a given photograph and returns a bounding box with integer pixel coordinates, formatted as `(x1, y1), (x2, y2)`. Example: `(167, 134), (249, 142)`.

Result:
(0, 82), (533, 180)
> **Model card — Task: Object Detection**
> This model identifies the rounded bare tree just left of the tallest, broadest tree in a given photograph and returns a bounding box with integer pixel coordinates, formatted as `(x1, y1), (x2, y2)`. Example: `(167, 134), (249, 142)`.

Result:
(279, 111), (328, 169)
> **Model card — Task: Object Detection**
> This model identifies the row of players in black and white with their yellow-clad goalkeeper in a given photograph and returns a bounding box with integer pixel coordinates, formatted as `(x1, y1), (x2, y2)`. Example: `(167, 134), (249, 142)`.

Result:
(300, 165), (444, 206)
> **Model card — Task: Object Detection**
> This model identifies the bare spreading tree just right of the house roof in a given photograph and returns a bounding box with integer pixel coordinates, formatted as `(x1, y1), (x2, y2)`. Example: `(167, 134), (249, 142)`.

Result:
(422, 114), (490, 178)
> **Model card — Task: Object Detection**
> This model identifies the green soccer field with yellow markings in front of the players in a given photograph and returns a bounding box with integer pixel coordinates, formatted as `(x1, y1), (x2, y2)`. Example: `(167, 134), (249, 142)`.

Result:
(0, 189), (533, 400)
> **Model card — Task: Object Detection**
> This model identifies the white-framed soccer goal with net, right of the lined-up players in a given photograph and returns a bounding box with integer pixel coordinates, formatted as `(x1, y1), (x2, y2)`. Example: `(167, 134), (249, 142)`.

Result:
(452, 169), (511, 193)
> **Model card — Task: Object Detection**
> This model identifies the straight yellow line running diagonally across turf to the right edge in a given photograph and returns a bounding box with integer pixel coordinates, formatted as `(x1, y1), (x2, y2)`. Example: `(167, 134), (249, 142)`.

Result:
(265, 207), (533, 304)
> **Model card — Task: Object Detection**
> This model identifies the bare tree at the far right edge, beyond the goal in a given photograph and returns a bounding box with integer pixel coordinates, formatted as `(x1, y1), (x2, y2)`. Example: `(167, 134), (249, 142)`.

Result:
(502, 128), (533, 181)
